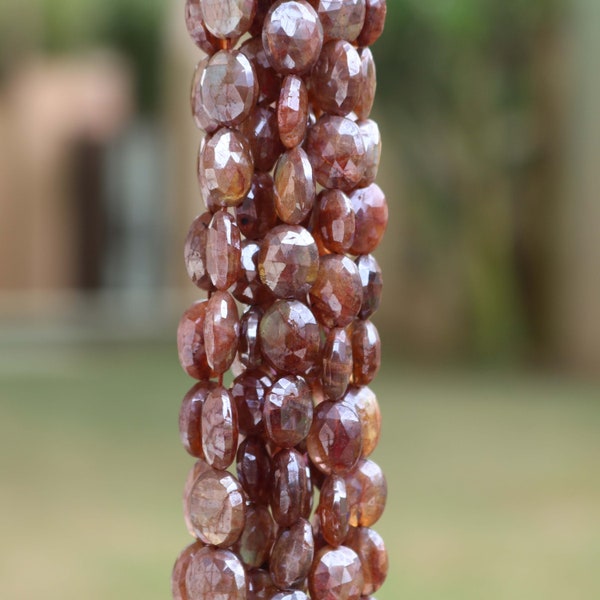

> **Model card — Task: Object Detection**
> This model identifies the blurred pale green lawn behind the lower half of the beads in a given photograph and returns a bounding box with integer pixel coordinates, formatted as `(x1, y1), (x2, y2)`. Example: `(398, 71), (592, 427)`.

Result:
(0, 344), (600, 600)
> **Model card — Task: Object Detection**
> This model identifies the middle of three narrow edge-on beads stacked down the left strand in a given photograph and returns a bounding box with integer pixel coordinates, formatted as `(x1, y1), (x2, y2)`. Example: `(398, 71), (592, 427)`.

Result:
(204, 292), (240, 373)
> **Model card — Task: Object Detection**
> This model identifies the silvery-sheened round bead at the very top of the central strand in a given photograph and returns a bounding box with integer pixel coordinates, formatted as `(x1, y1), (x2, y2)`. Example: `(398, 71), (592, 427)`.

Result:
(262, 0), (323, 75)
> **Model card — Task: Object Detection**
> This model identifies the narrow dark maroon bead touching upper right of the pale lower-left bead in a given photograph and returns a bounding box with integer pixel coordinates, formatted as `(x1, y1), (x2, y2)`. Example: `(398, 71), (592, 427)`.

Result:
(236, 436), (272, 504)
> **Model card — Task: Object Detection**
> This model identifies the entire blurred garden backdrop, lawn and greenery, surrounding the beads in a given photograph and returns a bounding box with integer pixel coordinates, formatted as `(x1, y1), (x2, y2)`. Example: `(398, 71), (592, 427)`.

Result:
(0, 0), (600, 600)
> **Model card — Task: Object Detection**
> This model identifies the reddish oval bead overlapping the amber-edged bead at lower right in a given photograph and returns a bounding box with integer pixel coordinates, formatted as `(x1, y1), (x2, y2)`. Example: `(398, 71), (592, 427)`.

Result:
(307, 401), (362, 475)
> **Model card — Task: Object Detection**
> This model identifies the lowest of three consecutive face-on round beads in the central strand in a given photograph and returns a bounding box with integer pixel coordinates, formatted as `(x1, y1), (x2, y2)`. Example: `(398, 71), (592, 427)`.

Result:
(263, 375), (313, 448)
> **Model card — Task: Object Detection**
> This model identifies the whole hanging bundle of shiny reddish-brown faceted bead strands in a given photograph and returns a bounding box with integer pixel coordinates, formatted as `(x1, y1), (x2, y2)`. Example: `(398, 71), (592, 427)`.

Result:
(172, 0), (387, 600)
